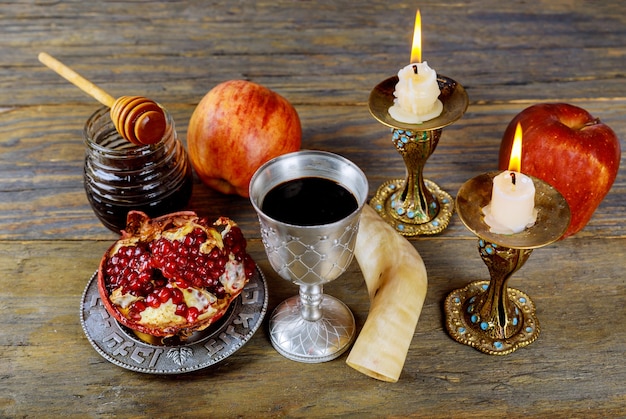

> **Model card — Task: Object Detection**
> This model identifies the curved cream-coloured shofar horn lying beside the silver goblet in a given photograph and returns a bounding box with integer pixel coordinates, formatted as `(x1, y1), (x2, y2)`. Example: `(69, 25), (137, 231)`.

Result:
(346, 205), (428, 382)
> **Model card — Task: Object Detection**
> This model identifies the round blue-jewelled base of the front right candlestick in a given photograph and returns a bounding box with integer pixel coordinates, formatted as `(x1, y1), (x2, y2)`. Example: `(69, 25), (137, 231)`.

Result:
(444, 281), (540, 355)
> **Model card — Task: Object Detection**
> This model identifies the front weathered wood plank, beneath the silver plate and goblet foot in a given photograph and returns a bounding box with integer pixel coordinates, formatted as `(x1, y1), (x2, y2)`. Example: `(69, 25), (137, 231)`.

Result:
(0, 238), (626, 417)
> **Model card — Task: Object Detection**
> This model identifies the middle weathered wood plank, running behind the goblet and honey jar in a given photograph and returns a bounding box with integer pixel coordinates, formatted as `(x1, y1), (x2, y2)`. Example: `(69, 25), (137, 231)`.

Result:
(0, 100), (626, 240)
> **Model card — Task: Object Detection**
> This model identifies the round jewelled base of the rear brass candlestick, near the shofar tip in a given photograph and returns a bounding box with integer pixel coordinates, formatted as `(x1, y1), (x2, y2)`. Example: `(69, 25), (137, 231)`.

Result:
(370, 179), (454, 236)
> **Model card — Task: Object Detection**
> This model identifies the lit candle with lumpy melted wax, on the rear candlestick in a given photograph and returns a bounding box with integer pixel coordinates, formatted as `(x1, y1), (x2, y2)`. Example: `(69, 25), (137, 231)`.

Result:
(388, 10), (443, 124)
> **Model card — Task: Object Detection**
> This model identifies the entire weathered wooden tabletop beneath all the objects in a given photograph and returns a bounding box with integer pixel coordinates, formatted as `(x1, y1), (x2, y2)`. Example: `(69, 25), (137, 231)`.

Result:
(0, 0), (626, 418)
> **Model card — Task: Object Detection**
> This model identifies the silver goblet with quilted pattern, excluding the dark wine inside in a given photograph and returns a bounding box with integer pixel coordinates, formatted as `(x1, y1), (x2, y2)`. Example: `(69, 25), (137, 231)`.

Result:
(250, 150), (369, 363)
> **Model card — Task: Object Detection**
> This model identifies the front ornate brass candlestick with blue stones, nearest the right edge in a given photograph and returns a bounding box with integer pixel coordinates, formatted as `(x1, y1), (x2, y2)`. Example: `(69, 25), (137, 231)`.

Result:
(444, 172), (570, 355)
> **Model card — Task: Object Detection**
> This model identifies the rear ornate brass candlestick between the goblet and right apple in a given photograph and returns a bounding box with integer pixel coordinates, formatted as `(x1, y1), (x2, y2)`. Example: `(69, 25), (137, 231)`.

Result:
(369, 76), (469, 236)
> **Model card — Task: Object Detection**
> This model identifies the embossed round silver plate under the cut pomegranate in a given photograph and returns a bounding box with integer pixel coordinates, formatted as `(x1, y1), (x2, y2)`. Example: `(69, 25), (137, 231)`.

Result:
(80, 266), (268, 374)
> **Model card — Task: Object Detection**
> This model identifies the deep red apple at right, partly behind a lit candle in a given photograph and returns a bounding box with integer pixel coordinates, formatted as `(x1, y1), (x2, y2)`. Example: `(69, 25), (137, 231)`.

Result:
(499, 103), (621, 238)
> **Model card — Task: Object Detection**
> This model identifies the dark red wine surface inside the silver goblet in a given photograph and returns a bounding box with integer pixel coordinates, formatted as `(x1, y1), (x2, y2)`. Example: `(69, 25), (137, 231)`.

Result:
(261, 177), (359, 226)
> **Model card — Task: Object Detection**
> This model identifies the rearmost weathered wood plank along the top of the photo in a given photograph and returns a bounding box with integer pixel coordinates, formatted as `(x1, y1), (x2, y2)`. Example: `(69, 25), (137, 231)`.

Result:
(0, 1), (626, 106)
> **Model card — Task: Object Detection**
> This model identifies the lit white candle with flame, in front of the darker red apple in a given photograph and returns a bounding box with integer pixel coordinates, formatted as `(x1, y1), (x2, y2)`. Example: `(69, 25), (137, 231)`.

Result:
(483, 124), (537, 234)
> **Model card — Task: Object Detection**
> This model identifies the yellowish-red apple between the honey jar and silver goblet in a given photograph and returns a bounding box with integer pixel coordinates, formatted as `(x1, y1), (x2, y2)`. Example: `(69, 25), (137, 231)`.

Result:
(187, 80), (302, 197)
